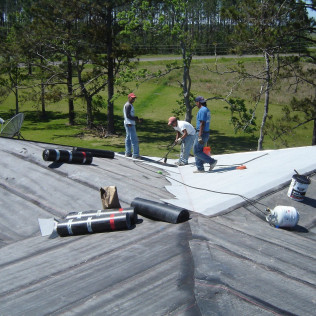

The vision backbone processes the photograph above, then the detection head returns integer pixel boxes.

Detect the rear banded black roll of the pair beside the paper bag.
[65,207,137,224]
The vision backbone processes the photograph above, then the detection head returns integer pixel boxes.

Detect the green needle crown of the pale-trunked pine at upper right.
[222,0,310,54]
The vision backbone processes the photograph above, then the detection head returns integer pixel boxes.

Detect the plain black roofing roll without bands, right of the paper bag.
[131,198,190,224]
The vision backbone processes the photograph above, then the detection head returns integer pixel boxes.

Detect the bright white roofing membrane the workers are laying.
[143,146,316,215]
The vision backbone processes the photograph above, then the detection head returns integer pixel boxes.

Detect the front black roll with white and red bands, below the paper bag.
[56,213,131,237]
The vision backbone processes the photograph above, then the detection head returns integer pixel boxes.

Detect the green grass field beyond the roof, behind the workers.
[0,58,313,158]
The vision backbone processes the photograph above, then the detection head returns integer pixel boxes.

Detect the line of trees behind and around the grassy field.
[0,0,316,149]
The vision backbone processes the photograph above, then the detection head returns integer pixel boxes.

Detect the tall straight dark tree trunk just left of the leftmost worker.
[106,6,115,135]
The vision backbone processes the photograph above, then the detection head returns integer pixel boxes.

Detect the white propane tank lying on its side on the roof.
[266,205,300,228]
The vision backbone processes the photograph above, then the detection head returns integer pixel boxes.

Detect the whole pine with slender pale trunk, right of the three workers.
[224,0,310,150]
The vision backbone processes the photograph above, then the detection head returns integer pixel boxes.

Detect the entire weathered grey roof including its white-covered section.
[0,138,316,315]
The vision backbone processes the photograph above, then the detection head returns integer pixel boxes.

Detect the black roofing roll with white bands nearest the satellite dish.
[43,149,93,165]
